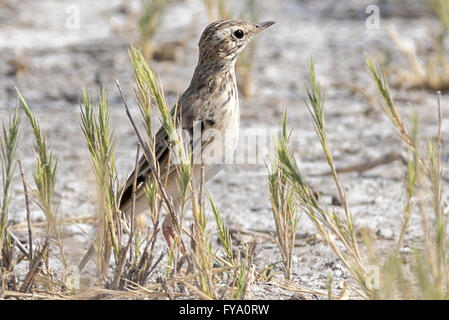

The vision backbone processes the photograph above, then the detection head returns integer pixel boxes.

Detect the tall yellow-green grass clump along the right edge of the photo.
[367,57,449,299]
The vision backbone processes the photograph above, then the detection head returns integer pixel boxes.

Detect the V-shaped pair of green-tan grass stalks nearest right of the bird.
[276,61,371,297]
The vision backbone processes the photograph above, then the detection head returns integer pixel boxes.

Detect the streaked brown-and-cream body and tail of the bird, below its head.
[120,66,240,214]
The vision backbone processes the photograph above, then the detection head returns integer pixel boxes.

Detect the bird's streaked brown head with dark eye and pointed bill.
[199,20,275,62]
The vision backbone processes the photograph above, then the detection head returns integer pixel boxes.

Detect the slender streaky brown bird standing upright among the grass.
[80,20,275,266]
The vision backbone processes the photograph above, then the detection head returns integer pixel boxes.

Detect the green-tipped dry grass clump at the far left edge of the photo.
[0,90,67,297]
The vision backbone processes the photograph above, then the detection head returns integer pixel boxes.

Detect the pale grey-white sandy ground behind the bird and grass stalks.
[0,0,449,299]
